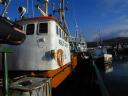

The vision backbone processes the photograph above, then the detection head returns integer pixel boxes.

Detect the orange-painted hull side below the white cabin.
[32,55,77,88]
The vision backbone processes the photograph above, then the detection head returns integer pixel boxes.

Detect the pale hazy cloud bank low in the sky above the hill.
[89,16,128,41]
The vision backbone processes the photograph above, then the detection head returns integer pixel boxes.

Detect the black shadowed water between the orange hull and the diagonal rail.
[53,57,101,96]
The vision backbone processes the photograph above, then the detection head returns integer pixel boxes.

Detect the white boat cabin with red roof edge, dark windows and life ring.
[9,16,71,71]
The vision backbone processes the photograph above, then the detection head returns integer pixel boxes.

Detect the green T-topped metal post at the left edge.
[0,47,13,96]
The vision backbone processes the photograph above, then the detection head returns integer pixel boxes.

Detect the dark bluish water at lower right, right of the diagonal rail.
[104,55,128,96]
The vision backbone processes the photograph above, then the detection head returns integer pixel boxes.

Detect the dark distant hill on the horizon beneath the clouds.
[87,37,128,47]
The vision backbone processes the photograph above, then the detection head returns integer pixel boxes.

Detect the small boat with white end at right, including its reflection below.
[94,46,113,73]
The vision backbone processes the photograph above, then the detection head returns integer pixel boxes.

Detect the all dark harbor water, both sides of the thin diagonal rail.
[53,56,128,96]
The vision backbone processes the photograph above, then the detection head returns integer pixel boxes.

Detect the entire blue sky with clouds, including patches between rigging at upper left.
[0,0,128,41]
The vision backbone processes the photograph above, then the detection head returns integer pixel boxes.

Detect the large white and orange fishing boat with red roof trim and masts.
[0,0,77,88]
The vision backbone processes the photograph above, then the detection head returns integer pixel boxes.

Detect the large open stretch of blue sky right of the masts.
[68,0,128,41]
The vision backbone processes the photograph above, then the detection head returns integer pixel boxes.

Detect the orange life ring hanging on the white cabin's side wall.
[57,49,64,66]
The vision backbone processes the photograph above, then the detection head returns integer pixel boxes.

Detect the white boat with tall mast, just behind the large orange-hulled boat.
[69,19,89,59]
